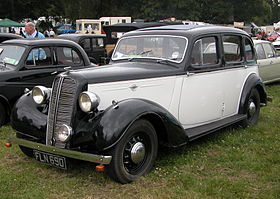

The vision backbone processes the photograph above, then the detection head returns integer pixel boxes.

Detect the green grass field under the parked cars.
[0,84,280,199]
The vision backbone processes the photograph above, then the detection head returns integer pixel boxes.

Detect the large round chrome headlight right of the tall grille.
[79,91,100,112]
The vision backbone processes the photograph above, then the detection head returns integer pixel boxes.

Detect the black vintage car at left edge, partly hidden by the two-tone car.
[0,39,95,125]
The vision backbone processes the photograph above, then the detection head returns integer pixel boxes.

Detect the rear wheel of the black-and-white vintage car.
[241,88,260,127]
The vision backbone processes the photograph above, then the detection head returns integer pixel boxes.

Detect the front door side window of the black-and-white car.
[191,37,218,68]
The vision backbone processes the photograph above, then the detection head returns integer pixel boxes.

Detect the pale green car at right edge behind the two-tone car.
[254,40,280,83]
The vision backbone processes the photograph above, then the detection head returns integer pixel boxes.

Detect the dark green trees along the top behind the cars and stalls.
[0,0,280,25]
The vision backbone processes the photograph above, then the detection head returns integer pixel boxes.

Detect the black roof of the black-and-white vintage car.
[122,24,249,36]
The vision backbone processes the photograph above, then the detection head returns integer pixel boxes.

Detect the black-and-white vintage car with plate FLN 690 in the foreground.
[6,25,267,183]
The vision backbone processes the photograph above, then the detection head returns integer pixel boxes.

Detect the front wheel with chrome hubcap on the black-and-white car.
[107,119,158,184]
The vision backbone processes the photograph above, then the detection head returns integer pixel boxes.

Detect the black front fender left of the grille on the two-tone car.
[11,92,47,143]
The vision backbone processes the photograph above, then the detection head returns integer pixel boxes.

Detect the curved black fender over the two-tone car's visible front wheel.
[73,99,187,151]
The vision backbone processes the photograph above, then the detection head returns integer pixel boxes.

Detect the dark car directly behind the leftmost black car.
[58,34,107,64]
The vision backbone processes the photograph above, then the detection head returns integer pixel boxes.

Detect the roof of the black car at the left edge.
[2,38,82,46]
